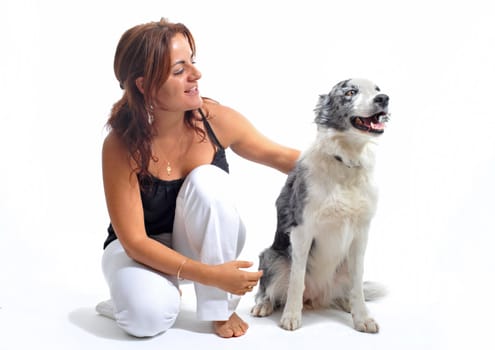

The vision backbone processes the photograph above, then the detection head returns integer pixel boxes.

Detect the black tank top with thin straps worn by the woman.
[103,110,229,248]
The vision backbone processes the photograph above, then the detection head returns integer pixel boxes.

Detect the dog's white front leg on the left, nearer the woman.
[280,226,312,331]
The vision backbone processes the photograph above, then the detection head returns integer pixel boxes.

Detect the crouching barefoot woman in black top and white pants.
[97,19,299,338]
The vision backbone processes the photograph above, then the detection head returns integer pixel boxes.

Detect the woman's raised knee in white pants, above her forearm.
[173,165,245,264]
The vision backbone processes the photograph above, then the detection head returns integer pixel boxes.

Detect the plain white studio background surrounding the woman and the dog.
[0,0,495,349]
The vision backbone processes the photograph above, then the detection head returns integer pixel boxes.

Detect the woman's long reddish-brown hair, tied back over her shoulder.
[107,18,204,183]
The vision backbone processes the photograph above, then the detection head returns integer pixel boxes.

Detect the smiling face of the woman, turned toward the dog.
[153,33,202,113]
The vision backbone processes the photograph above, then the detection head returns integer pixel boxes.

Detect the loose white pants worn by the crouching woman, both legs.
[102,165,245,337]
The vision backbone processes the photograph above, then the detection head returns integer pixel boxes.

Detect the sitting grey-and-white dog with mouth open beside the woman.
[251,79,389,333]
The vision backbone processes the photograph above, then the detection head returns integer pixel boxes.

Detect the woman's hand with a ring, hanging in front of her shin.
[211,260,263,295]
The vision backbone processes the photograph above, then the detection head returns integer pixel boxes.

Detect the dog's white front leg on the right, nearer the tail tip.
[348,230,379,333]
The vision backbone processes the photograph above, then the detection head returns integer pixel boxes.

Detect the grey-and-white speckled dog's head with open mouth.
[315,79,389,135]
